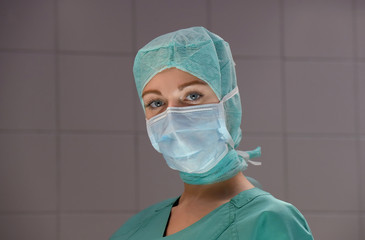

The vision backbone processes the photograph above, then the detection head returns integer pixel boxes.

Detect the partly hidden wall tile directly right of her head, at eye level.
[235,59,282,132]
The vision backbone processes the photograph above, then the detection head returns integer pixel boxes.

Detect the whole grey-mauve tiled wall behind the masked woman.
[0,0,365,240]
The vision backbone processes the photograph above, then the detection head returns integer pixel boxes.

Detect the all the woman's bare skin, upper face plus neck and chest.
[142,68,254,236]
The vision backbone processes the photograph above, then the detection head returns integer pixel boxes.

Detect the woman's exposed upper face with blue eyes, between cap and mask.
[142,68,219,119]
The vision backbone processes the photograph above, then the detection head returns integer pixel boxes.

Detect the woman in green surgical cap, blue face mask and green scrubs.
[111,27,313,240]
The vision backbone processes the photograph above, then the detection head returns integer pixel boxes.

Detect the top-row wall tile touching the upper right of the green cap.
[211,0,280,56]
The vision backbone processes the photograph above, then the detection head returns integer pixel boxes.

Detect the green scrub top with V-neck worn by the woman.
[110,188,313,240]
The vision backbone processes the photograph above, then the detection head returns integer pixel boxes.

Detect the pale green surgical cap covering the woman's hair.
[133,27,242,147]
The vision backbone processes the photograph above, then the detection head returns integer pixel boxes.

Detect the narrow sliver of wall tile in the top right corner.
[355,0,365,58]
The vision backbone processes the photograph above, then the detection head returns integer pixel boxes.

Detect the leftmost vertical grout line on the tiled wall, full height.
[54,0,61,240]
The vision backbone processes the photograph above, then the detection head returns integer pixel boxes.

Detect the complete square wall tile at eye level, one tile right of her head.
[286,62,355,133]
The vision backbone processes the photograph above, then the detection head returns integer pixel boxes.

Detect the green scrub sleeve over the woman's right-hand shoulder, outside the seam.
[232,191,313,240]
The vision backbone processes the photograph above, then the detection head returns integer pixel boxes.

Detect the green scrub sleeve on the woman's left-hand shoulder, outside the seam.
[110,198,177,240]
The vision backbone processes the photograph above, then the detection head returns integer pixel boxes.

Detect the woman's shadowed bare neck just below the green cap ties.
[179,172,254,205]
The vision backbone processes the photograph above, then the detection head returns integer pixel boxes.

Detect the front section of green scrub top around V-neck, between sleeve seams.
[138,188,267,240]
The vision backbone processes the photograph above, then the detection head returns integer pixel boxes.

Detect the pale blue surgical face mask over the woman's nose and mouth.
[147,88,238,173]
